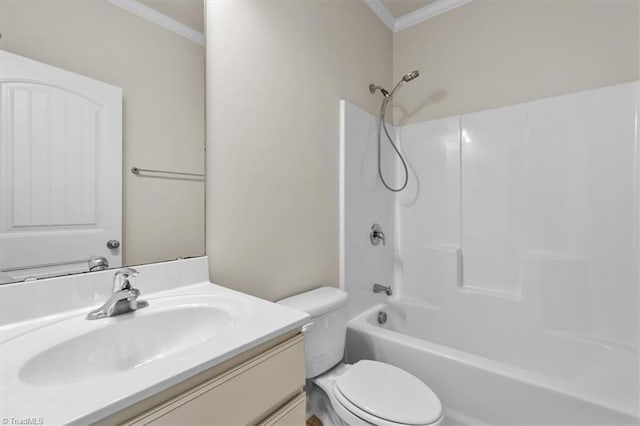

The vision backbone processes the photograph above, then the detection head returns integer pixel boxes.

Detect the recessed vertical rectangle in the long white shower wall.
[461,105,527,296]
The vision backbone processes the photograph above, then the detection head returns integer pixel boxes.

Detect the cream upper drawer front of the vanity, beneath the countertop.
[129,335,305,425]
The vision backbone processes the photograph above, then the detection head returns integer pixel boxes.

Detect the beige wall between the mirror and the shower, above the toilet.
[207,0,392,300]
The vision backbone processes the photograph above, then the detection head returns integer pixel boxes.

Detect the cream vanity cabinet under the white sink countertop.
[102,333,306,425]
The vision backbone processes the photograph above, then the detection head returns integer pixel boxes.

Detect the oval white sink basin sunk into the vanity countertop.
[18,306,233,385]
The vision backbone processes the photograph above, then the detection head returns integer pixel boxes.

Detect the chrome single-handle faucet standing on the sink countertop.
[87,268,149,320]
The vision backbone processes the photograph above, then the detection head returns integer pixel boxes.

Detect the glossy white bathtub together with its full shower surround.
[341,82,640,424]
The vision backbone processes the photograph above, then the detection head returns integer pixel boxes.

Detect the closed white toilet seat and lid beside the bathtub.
[314,360,442,426]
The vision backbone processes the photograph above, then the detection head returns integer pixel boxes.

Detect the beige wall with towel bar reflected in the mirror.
[0,0,204,264]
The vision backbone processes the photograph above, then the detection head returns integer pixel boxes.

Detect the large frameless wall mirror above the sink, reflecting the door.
[0,0,205,283]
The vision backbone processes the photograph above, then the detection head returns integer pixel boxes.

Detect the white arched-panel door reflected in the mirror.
[0,50,122,282]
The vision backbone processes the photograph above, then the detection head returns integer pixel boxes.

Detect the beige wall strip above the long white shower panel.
[393,0,640,123]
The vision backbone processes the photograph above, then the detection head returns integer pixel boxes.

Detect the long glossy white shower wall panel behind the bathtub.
[395,82,640,404]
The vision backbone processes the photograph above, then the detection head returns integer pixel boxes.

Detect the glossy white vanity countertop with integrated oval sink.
[0,272,308,425]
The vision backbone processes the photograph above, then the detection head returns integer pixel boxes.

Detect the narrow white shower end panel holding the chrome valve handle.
[340,101,397,316]
